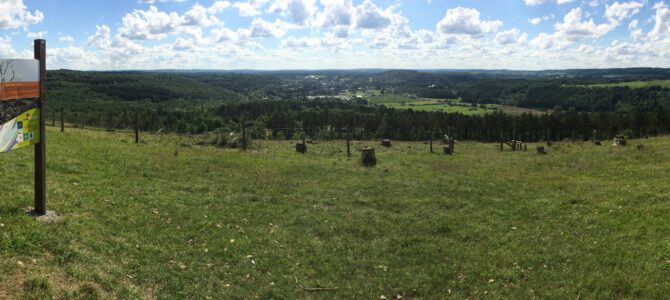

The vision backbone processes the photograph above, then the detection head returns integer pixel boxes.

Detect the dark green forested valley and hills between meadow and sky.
[42,69,670,141]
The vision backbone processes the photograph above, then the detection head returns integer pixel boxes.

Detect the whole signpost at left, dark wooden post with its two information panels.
[0,40,47,216]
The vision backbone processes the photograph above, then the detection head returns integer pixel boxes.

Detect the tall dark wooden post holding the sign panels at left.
[34,39,47,215]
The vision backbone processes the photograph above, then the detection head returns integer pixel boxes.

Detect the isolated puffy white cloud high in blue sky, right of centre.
[437,7,503,37]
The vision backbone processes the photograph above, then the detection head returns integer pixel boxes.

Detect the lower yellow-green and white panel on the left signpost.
[0,108,40,152]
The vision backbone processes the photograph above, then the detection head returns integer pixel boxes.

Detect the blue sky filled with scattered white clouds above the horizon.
[0,0,670,70]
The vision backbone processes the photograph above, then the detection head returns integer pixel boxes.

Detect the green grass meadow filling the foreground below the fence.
[0,128,670,299]
